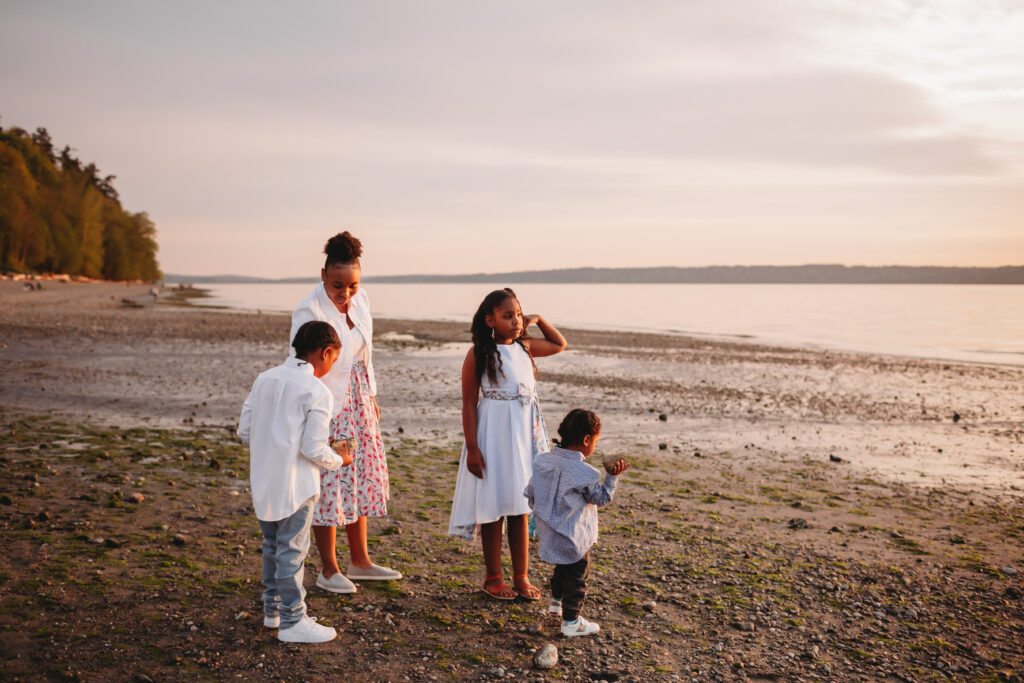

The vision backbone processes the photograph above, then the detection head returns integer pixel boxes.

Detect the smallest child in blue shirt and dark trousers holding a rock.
[523,408,630,637]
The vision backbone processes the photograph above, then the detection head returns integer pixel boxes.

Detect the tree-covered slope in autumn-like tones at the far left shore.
[0,122,161,281]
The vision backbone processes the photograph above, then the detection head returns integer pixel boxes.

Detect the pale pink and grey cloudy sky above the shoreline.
[0,0,1024,278]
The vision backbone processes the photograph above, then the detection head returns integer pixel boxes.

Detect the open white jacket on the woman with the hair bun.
[288,283,377,417]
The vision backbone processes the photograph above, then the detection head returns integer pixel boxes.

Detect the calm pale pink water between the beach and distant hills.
[184,284,1024,365]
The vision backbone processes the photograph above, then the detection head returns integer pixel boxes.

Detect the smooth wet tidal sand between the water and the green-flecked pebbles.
[0,282,1024,494]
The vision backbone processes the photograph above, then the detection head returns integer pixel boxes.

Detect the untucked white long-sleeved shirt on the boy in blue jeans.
[238,357,342,521]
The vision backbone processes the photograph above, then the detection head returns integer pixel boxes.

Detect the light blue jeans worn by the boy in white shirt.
[259,497,316,629]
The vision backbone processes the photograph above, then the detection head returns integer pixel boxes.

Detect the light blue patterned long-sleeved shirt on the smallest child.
[523,446,618,564]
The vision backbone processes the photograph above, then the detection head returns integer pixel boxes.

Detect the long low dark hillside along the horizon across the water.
[164,264,1024,285]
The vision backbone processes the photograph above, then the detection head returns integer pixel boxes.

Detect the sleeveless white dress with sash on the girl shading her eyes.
[449,343,551,539]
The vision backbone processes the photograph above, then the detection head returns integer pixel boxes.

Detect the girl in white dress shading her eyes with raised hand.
[449,288,565,600]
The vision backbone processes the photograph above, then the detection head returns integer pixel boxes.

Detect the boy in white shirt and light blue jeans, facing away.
[238,322,352,643]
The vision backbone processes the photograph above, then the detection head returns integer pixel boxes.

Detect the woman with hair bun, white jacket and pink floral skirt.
[292,231,401,593]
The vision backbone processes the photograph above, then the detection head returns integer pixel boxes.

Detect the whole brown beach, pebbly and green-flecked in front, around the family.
[0,281,1024,681]
